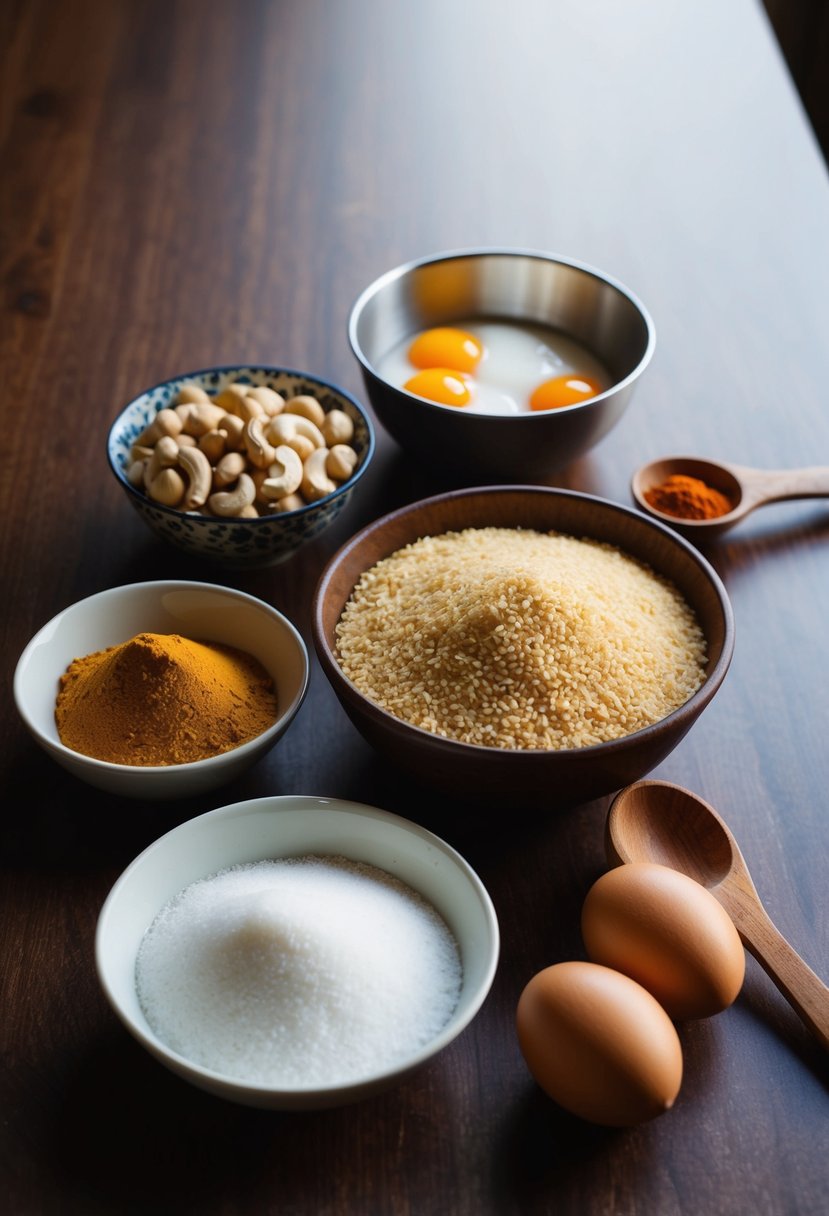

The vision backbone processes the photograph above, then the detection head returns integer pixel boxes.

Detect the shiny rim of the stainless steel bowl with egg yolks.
[348,246,656,427]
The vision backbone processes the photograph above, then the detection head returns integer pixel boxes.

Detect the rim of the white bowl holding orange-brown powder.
[12,579,311,779]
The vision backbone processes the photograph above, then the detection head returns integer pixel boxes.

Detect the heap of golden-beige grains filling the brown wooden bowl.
[337,528,706,749]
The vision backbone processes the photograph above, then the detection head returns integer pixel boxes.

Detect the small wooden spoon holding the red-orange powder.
[631,456,829,539]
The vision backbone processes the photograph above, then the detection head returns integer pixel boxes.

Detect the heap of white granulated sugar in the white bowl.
[136,856,461,1088]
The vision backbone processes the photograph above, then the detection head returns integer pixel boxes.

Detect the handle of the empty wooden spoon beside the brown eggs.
[716,890,829,1049]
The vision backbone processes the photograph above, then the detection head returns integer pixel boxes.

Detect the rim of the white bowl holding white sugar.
[95,794,501,1105]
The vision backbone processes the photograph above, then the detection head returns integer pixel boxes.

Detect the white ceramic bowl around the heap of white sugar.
[95,796,500,1109]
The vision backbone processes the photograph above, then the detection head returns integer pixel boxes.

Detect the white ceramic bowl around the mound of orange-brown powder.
[15,581,309,799]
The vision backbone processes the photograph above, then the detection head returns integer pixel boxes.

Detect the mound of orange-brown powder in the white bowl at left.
[55,634,277,765]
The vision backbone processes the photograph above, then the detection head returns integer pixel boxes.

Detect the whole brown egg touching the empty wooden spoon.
[581,862,745,1020]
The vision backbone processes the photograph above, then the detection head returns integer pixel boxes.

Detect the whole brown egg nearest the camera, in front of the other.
[515,962,682,1127]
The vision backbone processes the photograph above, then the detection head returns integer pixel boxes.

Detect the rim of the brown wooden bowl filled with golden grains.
[311,484,735,749]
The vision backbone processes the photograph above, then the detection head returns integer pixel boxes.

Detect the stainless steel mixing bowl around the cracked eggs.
[348,248,655,482]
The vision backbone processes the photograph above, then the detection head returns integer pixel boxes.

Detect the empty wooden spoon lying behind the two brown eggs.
[605,781,829,1048]
